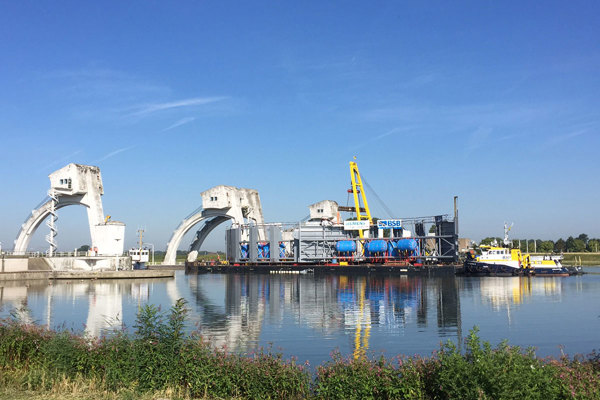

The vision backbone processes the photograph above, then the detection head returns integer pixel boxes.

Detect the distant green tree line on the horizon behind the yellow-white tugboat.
[479,233,600,253]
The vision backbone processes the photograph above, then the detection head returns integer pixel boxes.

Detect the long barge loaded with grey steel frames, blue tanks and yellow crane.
[186,162,458,273]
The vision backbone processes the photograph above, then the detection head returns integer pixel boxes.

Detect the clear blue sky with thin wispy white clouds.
[0,1,600,250]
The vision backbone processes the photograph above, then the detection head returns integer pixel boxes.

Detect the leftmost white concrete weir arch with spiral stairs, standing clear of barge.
[13,163,125,270]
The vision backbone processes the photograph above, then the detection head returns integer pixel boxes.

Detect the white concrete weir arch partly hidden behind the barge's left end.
[164,185,265,265]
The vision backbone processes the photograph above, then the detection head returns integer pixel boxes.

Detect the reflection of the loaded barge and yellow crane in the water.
[189,274,460,357]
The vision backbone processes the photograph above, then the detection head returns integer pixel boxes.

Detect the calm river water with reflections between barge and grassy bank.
[0,268,600,365]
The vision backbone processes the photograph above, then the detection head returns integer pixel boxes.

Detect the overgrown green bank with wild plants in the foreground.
[0,300,600,400]
